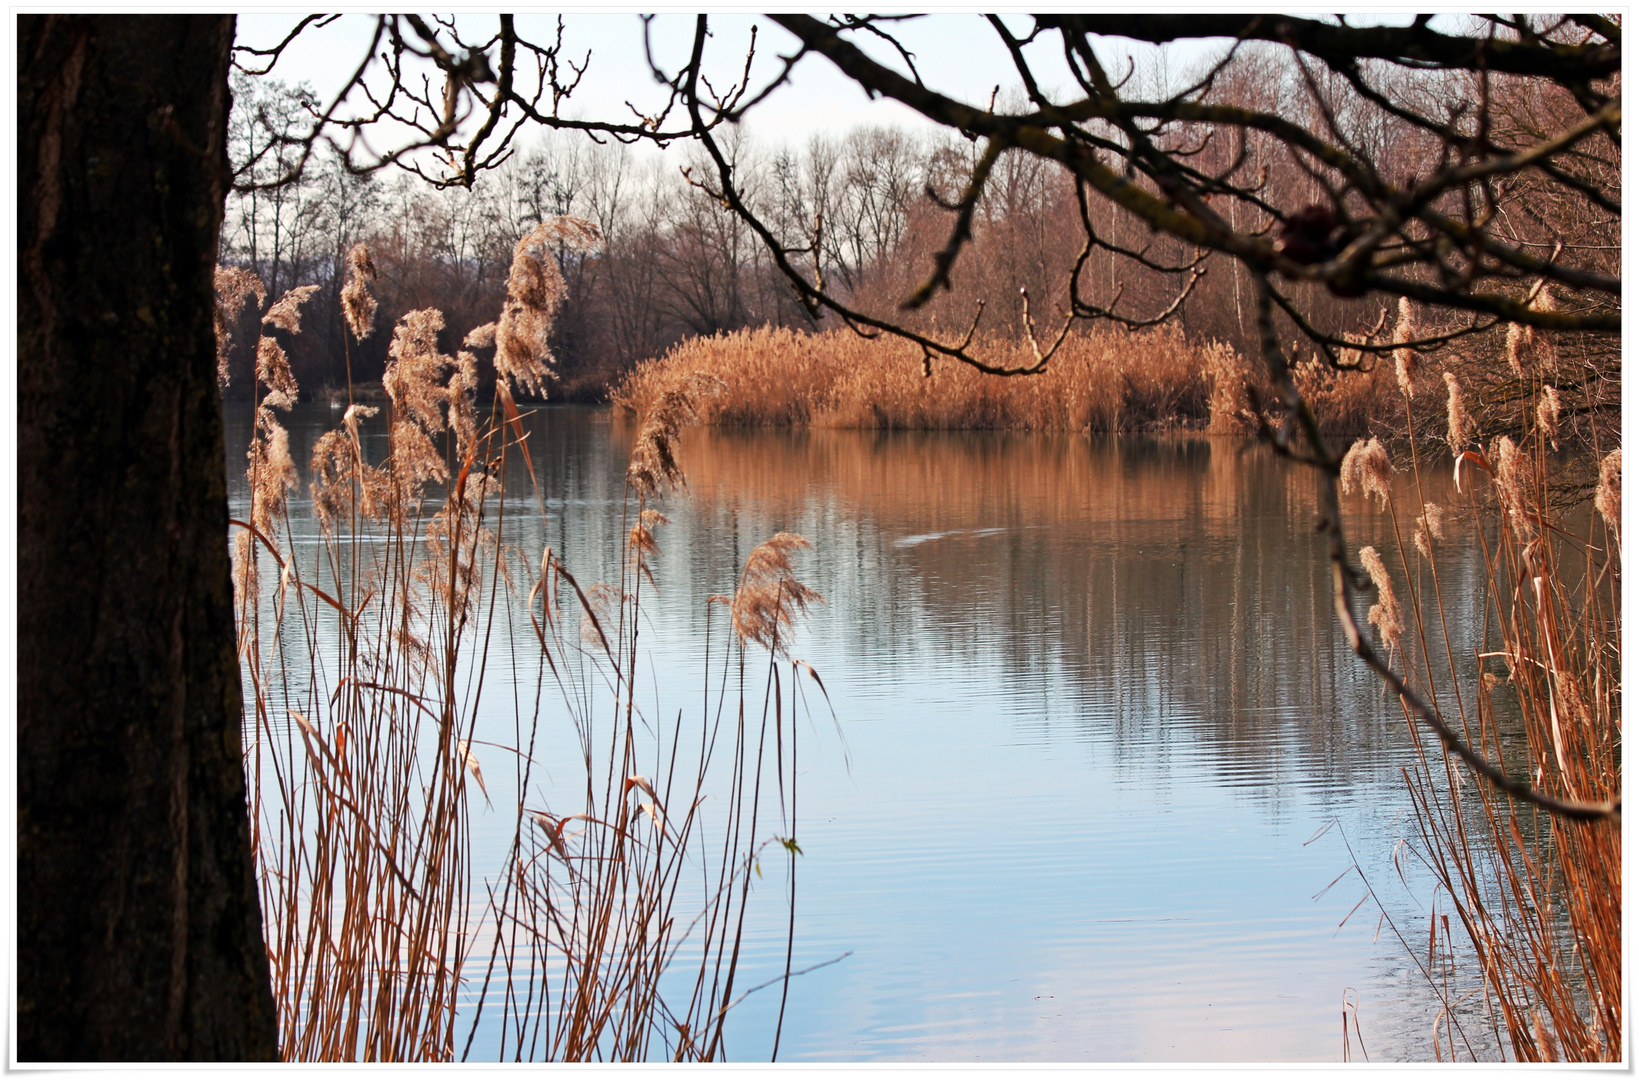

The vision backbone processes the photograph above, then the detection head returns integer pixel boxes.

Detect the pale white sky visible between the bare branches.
[239,13,1216,163]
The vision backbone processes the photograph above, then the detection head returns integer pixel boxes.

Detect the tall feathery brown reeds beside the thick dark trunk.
[227,220,818,1062]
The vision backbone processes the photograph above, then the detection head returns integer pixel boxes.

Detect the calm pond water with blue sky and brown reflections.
[229,406,1501,1062]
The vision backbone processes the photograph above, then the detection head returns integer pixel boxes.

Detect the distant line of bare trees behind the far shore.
[221,49,1621,455]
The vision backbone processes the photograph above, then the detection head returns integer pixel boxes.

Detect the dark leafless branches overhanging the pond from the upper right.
[243,15,1621,818]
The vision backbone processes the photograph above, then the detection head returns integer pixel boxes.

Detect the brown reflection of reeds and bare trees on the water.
[237,410,1483,812]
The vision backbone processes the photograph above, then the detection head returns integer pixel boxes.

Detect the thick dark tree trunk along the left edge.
[16,15,275,1060]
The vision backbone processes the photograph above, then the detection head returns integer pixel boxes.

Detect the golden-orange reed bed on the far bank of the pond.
[610,326,1395,433]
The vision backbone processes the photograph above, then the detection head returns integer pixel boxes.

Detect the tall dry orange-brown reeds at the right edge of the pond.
[1344,375,1623,1062]
